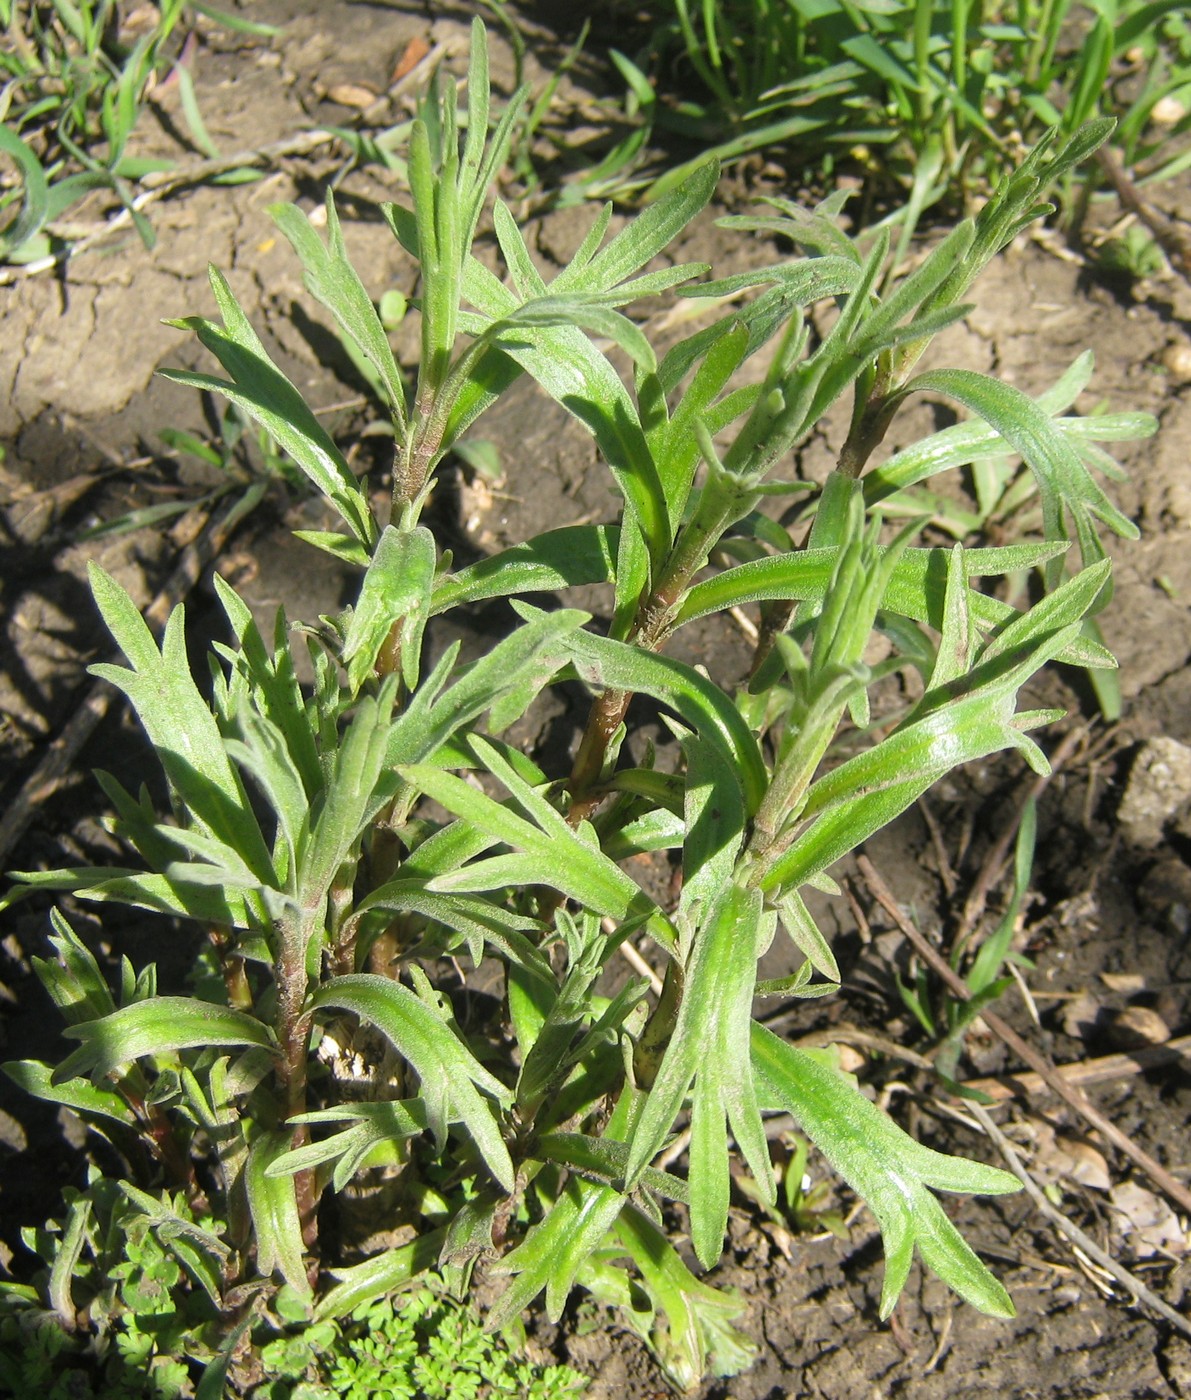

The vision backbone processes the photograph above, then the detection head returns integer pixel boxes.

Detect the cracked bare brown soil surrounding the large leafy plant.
[0,0,1191,1400]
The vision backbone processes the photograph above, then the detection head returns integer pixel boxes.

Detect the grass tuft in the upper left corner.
[0,0,276,262]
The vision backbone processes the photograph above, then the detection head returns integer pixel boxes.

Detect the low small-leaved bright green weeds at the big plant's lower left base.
[0,1170,586,1400]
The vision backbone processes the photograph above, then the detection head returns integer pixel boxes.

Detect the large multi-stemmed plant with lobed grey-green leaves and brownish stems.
[0,25,1153,1386]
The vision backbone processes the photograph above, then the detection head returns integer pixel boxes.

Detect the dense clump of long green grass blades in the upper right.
[617,0,1191,218]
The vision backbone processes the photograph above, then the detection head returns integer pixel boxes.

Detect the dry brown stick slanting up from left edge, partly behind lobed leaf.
[0,487,260,864]
